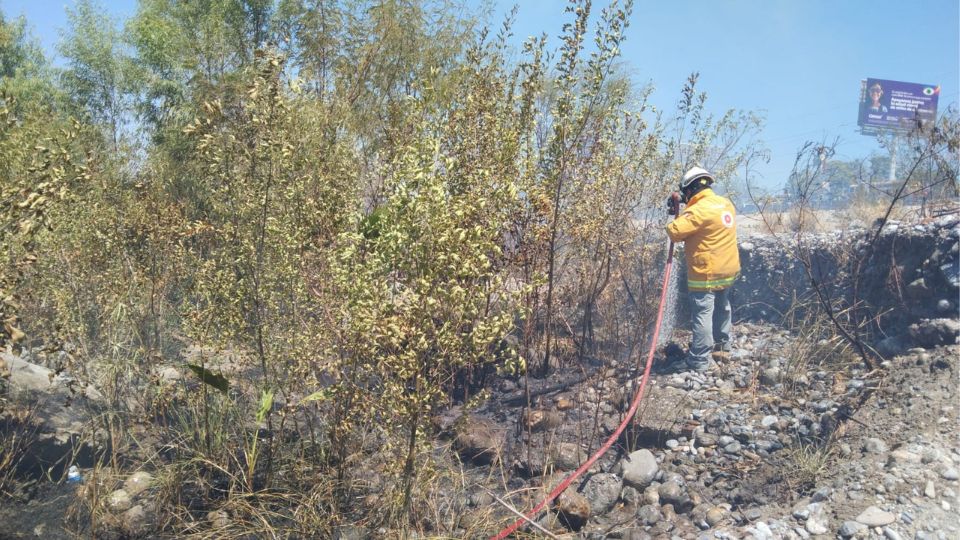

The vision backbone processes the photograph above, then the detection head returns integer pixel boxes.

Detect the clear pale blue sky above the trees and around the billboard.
[0,0,960,190]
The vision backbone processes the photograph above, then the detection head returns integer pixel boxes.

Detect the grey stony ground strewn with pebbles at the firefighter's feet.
[446,324,960,539]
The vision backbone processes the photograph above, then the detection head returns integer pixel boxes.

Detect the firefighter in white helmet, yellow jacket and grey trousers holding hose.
[667,167,740,372]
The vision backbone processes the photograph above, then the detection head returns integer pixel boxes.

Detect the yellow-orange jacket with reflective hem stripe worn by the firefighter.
[667,188,740,291]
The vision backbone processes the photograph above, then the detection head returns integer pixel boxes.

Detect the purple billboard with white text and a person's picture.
[857,79,940,135]
